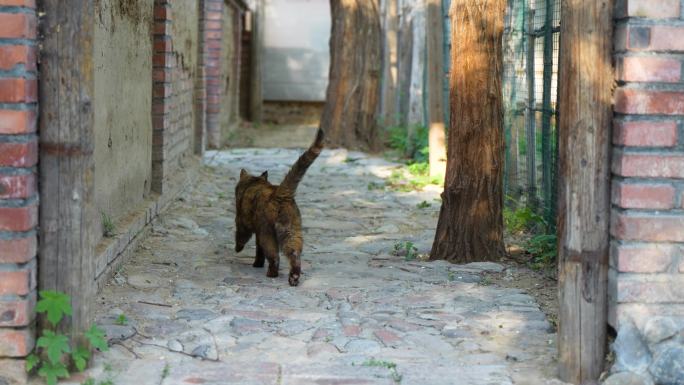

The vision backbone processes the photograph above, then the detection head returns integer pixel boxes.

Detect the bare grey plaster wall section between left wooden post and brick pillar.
[93,0,153,228]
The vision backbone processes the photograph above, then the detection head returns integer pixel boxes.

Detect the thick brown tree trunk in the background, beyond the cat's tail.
[321,0,382,150]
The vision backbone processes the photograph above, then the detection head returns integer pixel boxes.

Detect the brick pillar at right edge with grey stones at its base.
[609,0,684,384]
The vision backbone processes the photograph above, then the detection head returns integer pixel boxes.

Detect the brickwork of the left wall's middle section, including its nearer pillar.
[152,0,197,193]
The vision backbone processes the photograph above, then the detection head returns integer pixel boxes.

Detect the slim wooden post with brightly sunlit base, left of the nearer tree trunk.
[426,0,446,176]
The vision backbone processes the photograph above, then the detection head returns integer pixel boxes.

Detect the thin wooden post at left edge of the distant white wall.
[249,0,265,123]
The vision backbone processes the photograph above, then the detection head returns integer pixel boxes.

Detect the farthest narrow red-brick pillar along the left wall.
[200,0,224,148]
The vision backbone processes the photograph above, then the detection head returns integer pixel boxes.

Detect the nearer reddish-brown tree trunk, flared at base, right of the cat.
[430,0,505,263]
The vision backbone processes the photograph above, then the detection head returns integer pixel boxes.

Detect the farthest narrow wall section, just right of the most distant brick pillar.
[219,6,239,144]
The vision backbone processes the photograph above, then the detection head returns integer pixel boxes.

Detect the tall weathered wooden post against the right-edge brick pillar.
[558,0,614,384]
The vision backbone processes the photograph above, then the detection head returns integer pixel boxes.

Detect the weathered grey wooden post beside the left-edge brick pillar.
[38,0,99,339]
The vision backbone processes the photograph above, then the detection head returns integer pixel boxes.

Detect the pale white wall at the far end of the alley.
[262,0,331,101]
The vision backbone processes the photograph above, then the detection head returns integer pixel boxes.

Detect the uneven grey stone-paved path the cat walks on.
[58,149,560,385]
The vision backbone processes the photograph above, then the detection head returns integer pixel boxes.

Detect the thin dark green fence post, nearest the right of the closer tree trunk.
[525,4,537,208]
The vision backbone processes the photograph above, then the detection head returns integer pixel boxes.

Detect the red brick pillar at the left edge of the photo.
[0,0,38,384]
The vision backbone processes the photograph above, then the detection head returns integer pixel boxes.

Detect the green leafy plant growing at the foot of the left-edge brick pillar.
[26,290,108,385]
